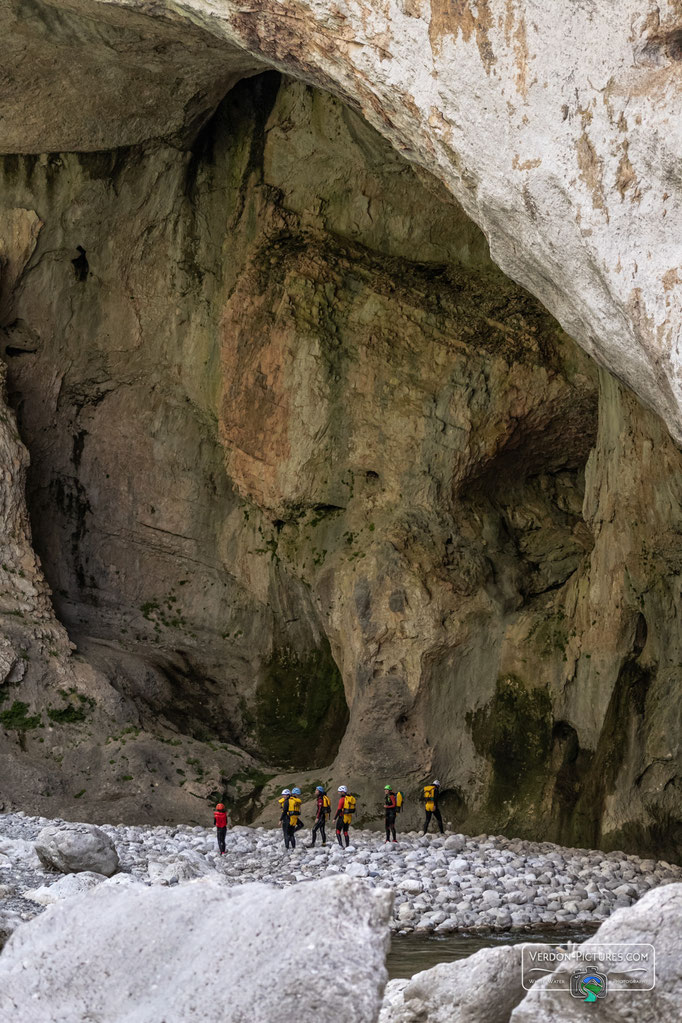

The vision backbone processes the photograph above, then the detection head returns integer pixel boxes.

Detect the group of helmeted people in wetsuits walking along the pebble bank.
[214,781,443,856]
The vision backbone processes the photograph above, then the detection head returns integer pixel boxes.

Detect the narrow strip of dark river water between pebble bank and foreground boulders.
[387,930,594,980]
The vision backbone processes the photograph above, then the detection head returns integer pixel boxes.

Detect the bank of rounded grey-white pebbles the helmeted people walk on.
[0,813,682,935]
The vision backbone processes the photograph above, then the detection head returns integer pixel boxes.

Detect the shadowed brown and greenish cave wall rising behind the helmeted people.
[0,69,682,856]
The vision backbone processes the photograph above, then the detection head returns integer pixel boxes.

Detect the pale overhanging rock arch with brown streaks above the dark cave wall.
[0,0,682,442]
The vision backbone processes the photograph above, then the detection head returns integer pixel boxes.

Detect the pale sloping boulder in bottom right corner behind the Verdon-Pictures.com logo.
[511,884,682,1023]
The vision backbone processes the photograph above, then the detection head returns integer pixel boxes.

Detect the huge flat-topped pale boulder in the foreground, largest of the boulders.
[0,877,393,1023]
